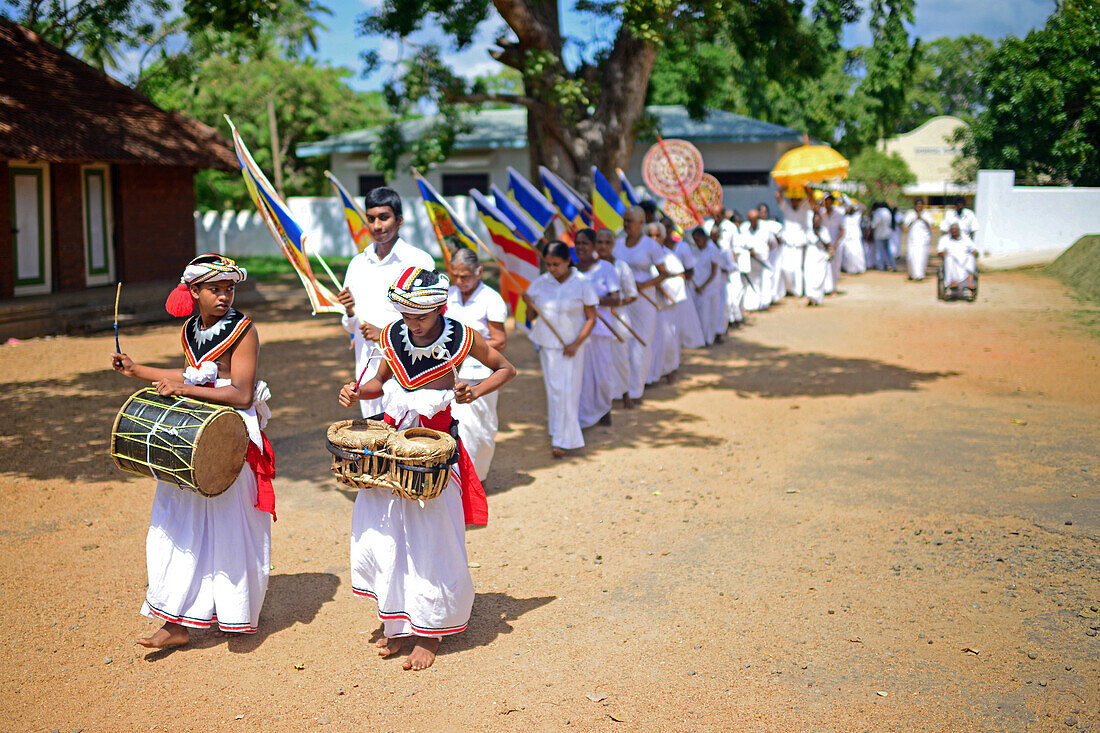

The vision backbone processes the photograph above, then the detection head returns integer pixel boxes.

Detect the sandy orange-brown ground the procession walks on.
[0,273,1100,732]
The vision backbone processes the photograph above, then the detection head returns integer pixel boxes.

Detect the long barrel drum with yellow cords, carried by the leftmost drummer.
[111,387,249,496]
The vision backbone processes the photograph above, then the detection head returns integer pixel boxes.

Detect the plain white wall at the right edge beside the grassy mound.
[975,171,1100,267]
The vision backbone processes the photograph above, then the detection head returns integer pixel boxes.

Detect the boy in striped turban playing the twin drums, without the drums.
[339,267,516,670]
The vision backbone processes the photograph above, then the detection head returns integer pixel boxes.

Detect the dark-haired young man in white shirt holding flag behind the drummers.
[337,187,436,417]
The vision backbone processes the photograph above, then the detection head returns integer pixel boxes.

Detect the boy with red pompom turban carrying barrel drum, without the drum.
[111,254,275,647]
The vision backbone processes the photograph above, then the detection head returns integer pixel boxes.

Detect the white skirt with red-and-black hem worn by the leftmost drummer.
[141,463,272,633]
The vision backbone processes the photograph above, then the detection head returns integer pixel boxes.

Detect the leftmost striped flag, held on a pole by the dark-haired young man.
[226,117,344,315]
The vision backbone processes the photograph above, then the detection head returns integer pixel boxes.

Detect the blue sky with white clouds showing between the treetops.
[317,0,1055,90]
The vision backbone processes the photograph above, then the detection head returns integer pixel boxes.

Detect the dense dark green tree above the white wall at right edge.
[964,0,1100,186]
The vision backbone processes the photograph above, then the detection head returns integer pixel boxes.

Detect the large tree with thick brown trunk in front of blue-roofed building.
[362,0,836,183]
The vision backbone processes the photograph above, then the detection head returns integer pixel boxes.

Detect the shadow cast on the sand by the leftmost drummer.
[145,572,340,661]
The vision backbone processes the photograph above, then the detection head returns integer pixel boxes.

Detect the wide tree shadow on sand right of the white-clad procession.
[681,337,958,398]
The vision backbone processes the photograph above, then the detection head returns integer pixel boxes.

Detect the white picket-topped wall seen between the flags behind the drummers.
[195,196,488,258]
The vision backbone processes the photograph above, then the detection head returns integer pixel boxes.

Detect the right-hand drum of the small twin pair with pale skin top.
[388,427,459,500]
